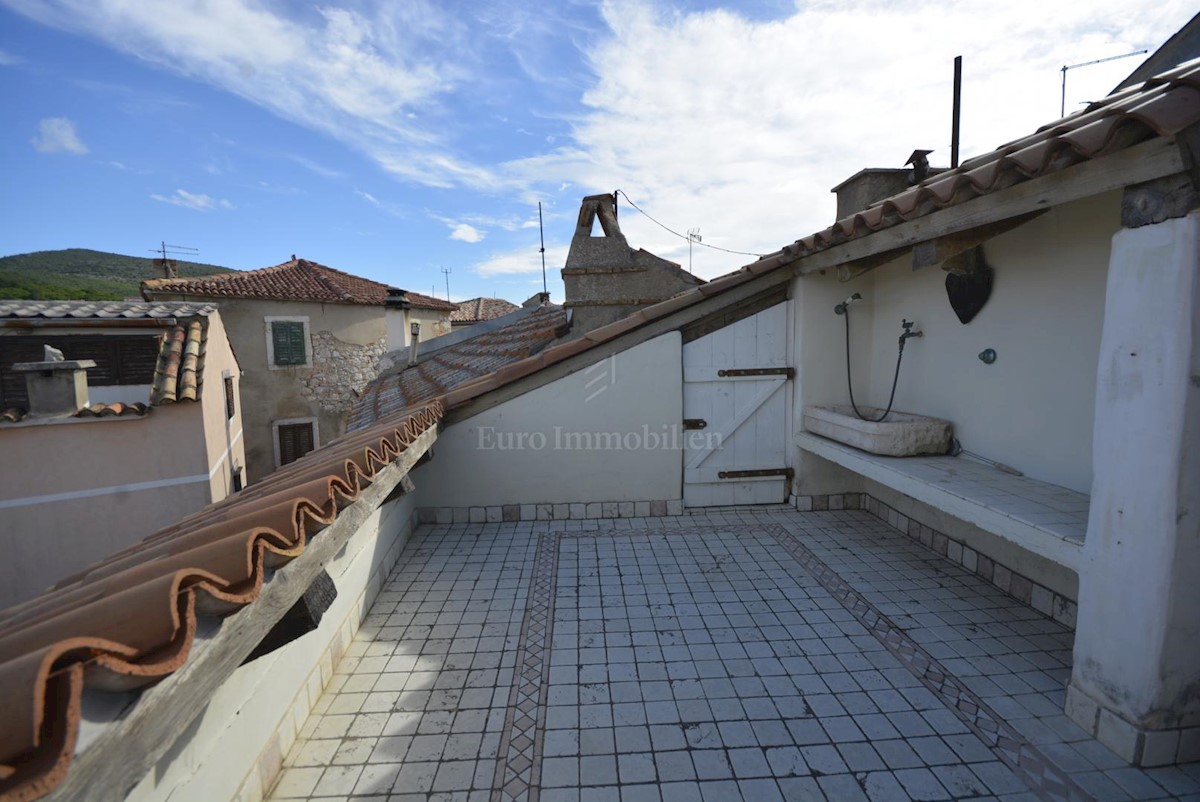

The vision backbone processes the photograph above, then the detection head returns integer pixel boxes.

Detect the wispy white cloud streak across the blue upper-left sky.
[5,0,496,187]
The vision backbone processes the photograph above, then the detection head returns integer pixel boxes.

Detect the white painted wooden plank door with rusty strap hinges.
[683,303,791,507]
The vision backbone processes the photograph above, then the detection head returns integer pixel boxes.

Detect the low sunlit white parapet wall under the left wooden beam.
[126,493,415,802]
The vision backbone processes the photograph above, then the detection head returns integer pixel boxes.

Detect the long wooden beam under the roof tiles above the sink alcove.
[794,137,1184,275]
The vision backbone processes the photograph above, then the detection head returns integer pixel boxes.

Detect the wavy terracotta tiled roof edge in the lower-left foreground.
[0,402,442,802]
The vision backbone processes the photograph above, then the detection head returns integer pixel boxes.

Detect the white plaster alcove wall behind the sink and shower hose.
[796,192,1121,492]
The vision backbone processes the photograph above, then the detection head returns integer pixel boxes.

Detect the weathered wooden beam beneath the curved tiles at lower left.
[44,426,438,802]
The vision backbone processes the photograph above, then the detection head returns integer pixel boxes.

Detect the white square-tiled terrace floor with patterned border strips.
[272,508,1200,802]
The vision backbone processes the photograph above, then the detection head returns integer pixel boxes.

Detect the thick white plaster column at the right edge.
[1062,211,1200,766]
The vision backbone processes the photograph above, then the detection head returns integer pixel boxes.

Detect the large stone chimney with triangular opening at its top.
[563,194,704,335]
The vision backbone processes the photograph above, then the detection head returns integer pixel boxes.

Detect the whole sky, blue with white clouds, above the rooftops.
[0,0,1193,301]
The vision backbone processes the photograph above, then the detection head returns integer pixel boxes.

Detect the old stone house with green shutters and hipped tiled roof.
[142,257,456,483]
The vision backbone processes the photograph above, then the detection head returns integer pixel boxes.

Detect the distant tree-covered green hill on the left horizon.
[0,247,232,300]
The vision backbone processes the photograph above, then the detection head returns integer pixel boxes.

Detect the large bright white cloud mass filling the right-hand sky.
[505,0,1194,277]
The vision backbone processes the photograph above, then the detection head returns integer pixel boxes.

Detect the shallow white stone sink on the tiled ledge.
[804,406,954,456]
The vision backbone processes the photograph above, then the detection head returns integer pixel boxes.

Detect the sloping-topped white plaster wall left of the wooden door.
[414,331,683,507]
